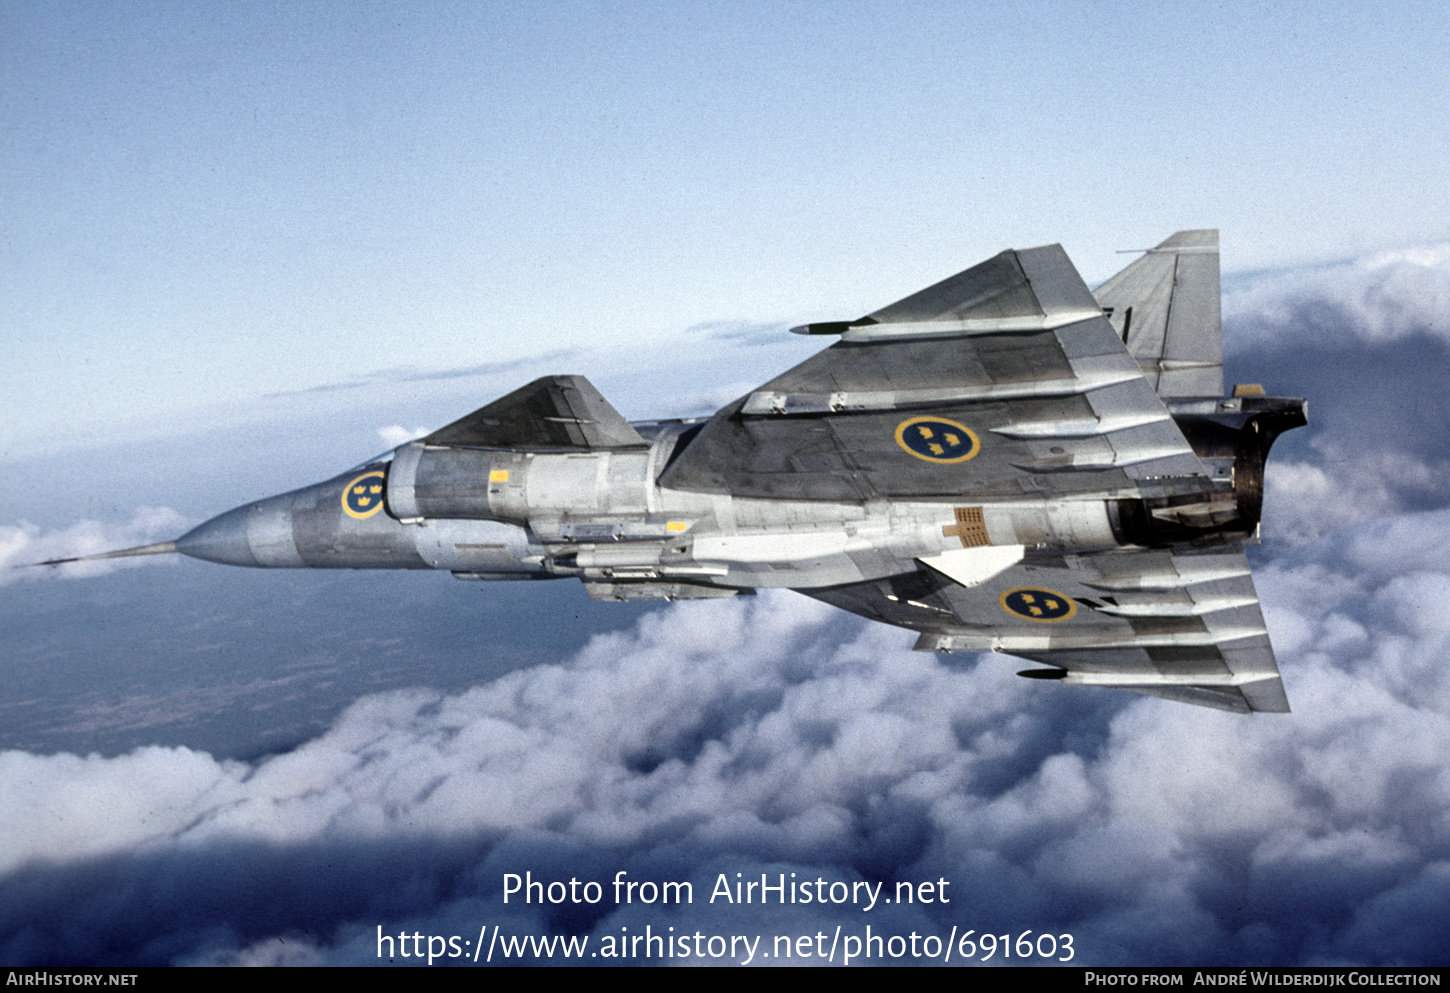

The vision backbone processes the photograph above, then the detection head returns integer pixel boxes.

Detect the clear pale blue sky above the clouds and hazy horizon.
[0,3,1450,455]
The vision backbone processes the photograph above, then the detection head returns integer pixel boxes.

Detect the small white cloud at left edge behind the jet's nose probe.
[0,507,193,586]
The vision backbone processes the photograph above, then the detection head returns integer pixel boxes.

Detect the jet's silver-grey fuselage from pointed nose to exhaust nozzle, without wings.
[177,397,1302,599]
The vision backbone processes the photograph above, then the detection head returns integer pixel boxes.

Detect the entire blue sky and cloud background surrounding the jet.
[0,3,1450,965]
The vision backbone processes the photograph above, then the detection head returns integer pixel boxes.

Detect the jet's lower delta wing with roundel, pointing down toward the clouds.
[806,549,1289,713]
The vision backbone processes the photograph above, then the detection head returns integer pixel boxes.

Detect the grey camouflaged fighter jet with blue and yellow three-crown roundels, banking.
[49,230,1306,713]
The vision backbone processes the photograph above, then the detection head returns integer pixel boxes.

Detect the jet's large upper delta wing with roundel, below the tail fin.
[660,245,1212,500]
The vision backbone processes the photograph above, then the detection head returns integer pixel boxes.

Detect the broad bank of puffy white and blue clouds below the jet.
[8,512,1450,964]
